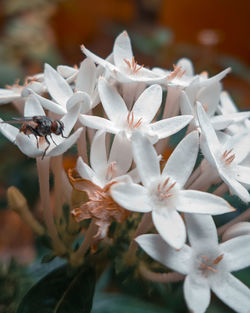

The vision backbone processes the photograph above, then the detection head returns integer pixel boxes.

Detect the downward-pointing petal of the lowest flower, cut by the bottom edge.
[183,275,211,313]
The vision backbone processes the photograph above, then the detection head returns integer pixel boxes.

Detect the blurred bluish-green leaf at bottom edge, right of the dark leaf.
[91,293,173,313]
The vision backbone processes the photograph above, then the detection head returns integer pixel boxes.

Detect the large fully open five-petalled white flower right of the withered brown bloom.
[111,131,231,249]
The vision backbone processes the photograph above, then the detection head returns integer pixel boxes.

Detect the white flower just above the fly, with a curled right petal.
[30,64,91,115]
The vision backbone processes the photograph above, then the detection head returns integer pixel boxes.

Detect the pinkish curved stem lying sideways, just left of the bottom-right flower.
[139,265,185,283]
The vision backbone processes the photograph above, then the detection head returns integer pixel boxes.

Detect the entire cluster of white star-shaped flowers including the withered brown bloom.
[0,32,250,313]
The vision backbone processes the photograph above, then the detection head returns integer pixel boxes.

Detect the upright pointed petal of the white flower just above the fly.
[44,64,73,105]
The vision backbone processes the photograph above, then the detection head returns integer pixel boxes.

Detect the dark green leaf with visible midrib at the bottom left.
[16,265,95,313]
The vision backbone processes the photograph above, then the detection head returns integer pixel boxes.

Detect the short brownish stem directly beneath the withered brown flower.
[70,219,97,266]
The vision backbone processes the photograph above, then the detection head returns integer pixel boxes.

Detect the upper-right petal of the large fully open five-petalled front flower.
[162,131,199,187]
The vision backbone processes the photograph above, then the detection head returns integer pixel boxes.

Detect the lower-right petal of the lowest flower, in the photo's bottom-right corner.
[211,273,250,313]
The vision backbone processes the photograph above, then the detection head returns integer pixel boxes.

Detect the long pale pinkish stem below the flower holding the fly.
[36,157,66,255]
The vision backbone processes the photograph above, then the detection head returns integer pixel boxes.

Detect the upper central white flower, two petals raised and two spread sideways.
[79,78,192,143]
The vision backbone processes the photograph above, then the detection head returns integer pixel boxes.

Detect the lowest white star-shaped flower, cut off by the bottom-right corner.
[136,214,250,313]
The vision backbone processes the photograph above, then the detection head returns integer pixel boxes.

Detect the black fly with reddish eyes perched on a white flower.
[1,116,68,159]
